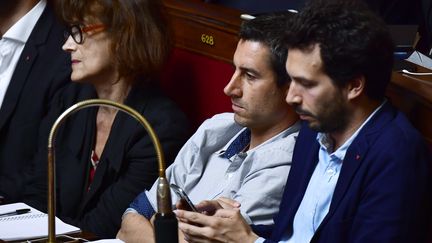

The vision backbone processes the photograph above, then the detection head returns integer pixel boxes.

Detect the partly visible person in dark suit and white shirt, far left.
[0,0,70,203]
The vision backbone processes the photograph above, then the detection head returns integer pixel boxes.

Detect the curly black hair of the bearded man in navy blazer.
[285,0,394,100]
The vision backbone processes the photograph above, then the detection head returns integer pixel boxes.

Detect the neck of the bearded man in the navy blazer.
[329,99,381,151]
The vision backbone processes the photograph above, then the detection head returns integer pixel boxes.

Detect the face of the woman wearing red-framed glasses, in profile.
[63,18,117,84]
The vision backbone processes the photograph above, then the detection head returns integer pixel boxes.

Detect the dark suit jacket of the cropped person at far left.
[0,3,71,203]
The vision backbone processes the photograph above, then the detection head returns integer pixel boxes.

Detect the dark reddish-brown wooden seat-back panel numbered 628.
[163,0,241,63]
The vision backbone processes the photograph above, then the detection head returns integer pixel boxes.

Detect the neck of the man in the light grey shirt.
[249,112,298,149]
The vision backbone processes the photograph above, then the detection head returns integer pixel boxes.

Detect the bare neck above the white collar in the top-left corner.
[0,0,39,35]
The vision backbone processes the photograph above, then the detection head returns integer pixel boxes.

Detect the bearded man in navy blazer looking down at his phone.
[177,1,432,243]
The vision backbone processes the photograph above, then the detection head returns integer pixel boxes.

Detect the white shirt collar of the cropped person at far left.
[3,0,47,43]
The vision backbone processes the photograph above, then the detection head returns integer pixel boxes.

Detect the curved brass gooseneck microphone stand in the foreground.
[48,99,178,243]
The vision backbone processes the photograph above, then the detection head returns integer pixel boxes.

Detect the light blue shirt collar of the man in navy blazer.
[316,100,387,161]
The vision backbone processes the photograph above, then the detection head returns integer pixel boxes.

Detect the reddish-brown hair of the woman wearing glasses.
[55,0,172,80]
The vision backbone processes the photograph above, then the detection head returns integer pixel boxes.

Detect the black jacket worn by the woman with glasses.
[25,83,189,238]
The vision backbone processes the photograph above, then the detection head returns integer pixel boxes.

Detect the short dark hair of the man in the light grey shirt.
[239,11,294,85]
